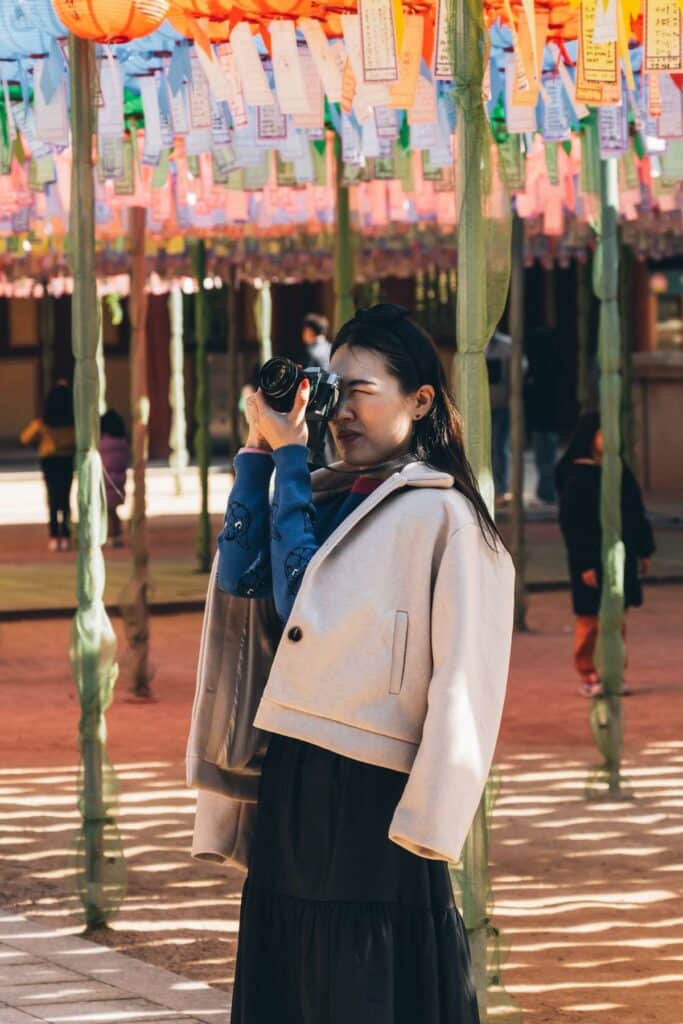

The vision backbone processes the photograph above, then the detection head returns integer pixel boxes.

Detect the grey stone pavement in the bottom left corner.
[0,910,229,1024]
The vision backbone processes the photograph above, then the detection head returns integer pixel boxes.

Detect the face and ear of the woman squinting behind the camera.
[330,345,434,469]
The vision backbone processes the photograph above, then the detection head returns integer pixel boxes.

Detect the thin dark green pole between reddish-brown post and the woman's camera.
[193,241,211,572]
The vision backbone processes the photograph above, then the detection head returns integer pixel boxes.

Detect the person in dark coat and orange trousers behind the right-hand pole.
[555,413,654,696]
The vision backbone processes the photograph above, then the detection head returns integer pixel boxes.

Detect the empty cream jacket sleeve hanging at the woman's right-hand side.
[389,524,514,861]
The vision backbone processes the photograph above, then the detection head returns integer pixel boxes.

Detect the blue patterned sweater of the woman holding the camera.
[218,444,379,622]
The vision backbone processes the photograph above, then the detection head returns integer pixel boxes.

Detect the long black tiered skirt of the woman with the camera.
[231,734,479,1024]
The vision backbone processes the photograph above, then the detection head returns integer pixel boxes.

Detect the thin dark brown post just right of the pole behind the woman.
[509,213,526,632]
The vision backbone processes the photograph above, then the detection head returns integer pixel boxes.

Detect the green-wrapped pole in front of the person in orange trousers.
[591,158,625,796]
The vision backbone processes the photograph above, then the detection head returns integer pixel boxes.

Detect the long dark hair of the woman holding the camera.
[330,302,502,548]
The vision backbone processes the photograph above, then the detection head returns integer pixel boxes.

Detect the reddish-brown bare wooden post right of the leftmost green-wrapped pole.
[128,207,152,698]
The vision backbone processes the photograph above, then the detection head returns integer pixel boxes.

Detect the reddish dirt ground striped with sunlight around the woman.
[0,586,683,1024]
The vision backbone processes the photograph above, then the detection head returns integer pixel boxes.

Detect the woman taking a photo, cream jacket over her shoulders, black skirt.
[188,305,513,1024]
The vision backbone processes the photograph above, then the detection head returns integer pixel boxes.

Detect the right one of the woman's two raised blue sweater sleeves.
[270,444,318,622]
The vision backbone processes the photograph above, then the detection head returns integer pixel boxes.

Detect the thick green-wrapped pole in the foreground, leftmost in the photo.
[69,36,125,929]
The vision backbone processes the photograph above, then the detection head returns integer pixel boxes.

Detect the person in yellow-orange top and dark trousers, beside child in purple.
[20,380,76,551]
